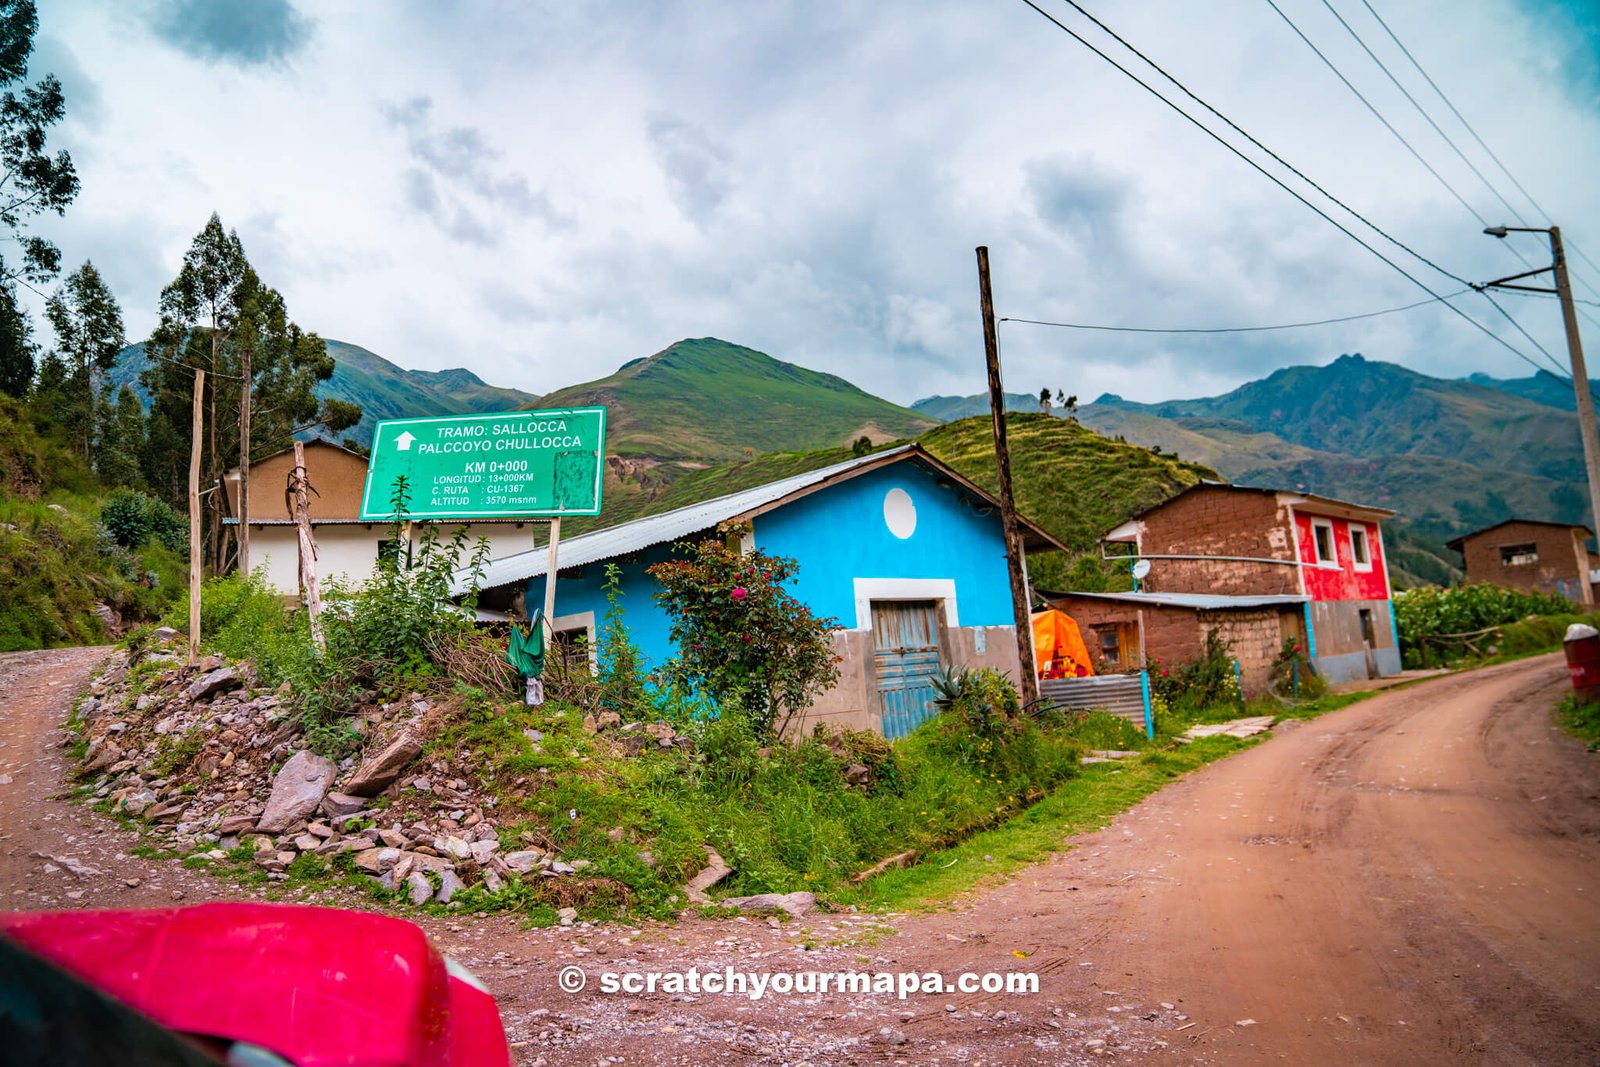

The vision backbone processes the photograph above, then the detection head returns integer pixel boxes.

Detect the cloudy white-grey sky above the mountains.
[34,0,1600,403]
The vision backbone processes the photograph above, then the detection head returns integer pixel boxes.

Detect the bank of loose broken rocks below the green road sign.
[74,630,611,920]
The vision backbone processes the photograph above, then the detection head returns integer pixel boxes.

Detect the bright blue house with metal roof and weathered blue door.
[464,445,1064,737]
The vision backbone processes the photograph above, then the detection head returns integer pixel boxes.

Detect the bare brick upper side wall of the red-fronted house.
[1141,486,1301,595]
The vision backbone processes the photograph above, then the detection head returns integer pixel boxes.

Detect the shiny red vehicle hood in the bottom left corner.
[0,904,510,1067]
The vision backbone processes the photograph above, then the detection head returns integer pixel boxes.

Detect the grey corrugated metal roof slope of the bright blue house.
[451,445,923,593]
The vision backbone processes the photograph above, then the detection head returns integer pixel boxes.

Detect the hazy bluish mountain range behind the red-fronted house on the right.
[915,355,1587,584]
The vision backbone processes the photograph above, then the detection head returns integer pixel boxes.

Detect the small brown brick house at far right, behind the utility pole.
[1448,518,1595,605]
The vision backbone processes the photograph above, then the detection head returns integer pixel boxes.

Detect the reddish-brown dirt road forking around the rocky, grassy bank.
[0,653,1600,1065]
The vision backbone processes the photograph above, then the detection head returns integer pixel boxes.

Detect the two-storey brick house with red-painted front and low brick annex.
[1054,482,1400,684]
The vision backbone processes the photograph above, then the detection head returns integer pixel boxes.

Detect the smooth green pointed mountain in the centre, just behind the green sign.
[538,338,936,462]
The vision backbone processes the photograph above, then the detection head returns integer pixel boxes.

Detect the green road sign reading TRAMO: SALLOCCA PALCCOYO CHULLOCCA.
[362,408,605,520]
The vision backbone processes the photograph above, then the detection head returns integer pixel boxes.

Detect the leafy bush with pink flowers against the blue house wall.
[650,526,838,737]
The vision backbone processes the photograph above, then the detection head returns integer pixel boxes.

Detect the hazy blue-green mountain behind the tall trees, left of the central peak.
[109,341,536,445]
